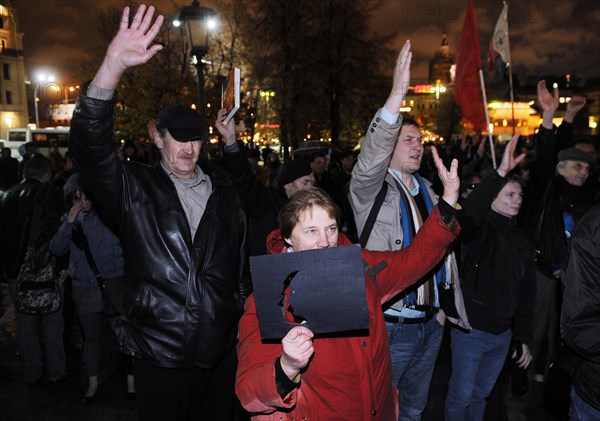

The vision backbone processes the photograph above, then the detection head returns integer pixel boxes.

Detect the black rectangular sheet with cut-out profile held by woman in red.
[250,245,369,339]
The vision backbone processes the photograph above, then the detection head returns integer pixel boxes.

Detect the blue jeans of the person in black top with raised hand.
[445,328,512,421]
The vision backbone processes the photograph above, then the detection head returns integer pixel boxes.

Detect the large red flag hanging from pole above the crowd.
[454,0,487,131]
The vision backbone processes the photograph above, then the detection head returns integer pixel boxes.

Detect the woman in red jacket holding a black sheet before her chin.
[236,147,460,421]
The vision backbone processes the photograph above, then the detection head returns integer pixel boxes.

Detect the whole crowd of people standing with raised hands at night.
[0,5,600,421]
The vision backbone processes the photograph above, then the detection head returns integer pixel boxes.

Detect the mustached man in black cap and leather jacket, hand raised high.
[69,5,248,420]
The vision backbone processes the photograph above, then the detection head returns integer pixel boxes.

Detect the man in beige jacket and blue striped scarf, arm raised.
[349,41,469,421]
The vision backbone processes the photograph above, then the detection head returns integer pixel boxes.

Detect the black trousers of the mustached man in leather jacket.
[133,348,237,421]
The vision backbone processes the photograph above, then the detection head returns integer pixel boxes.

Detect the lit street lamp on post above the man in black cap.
[173,0,216,111]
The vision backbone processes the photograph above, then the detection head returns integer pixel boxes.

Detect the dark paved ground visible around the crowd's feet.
[0,283,553,421]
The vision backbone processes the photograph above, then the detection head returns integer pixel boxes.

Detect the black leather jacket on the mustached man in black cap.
[69,87,249,368]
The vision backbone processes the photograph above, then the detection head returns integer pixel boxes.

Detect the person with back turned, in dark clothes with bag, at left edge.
[0,156,66,385]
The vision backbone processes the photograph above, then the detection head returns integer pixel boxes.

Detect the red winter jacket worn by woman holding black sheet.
[236,206,458,421]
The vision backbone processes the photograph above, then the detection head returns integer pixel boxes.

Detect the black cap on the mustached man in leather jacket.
[156,104,207,142]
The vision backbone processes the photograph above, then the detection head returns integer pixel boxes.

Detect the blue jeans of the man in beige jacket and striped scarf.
[386,317,444,421]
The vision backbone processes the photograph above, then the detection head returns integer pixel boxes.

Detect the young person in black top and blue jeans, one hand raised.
[445,135,536,421]
